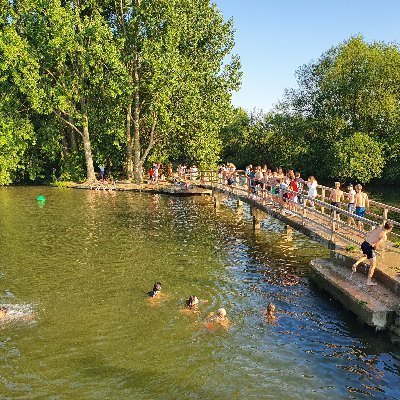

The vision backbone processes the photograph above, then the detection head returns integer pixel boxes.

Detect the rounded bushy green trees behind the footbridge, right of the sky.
[221,37,400,183]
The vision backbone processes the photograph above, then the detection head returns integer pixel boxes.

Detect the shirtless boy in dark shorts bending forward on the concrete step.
[352,222,393,286]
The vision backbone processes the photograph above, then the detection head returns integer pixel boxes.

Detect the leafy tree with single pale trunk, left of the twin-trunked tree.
[14,0,123,181]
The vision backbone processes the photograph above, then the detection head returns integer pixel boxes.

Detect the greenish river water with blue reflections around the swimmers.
[0,187,400,400]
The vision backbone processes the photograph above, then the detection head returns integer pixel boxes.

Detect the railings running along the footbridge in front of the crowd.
[199,170,400,252]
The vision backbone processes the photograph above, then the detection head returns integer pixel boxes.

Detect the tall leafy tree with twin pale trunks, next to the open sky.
[108,0,240,181]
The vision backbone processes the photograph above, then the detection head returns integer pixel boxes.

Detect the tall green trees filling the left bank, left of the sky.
[0,0,241,184]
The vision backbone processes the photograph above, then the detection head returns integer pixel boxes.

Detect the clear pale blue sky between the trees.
[213,0,400,111]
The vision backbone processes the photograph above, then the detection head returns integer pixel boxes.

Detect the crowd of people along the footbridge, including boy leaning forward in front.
[218,164,393,286]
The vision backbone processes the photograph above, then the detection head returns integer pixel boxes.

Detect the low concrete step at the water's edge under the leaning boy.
[310,259,399,330]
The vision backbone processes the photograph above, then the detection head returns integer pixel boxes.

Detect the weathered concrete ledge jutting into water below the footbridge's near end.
[310,259,395,330]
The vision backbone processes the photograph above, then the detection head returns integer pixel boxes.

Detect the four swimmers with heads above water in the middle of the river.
[147,282,276,329]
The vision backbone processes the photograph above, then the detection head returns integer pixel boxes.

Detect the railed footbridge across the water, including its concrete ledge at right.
[193,171,400,341]
